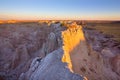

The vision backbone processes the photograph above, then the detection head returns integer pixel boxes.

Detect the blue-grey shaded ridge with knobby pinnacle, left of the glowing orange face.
[19,23,83,80]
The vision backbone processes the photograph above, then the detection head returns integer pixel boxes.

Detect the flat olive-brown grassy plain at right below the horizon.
[86,23,120,42]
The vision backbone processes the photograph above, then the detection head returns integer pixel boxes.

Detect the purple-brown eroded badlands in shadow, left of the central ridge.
[0,23,54,80]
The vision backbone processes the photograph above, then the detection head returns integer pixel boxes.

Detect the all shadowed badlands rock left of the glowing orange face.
[0,23,83,80]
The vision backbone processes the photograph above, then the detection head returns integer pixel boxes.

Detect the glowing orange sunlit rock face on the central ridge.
[62,23,85,71]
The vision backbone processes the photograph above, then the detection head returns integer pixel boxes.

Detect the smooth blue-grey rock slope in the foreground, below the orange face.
[19,48,83,80]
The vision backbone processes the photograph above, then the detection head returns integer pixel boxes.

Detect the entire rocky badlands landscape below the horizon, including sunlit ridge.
[0,21,120,80]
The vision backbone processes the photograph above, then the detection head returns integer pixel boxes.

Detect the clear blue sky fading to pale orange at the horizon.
[0,0,120,20]
